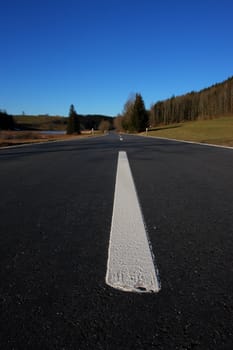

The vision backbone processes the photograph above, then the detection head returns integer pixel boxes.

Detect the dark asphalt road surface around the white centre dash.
[0,134,233,350]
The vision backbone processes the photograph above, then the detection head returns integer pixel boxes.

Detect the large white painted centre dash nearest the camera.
[106,151,160,292]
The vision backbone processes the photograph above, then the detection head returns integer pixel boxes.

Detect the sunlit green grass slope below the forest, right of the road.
[143,117,233,147]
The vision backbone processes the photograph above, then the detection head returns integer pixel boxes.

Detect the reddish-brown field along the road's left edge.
[0,131,102,147]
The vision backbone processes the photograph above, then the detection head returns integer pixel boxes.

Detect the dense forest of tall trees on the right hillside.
[149,77,233,126]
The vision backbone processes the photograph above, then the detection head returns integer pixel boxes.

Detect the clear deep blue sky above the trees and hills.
[0,0,233,116]
